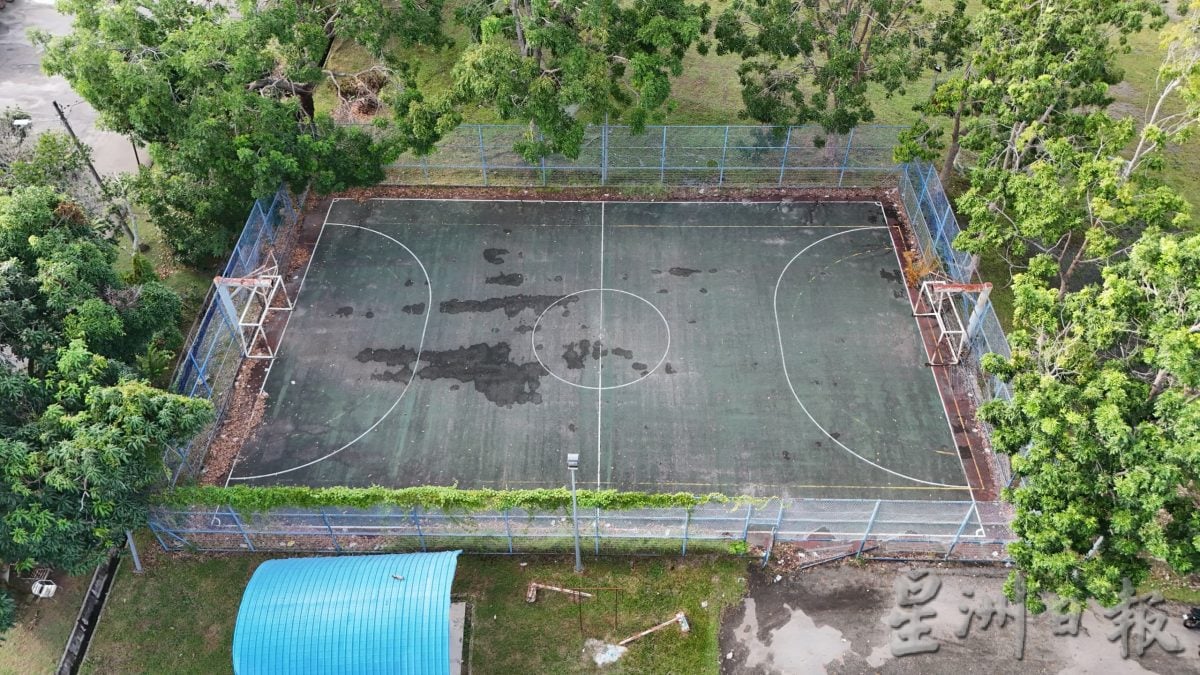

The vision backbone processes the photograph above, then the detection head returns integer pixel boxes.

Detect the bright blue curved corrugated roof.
[233,551,461,675]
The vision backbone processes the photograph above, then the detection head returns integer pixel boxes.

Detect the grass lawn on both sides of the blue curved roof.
[79,542,746,675]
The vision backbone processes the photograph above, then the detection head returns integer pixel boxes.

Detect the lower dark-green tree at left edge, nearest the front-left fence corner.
[0,340,212,574]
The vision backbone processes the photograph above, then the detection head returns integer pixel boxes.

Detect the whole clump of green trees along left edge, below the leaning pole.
[0,135,211,631]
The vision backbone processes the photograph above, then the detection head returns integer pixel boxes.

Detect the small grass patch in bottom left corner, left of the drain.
[0,574,91,675]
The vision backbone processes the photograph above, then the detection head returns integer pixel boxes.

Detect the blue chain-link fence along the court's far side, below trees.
[368,124,902,187]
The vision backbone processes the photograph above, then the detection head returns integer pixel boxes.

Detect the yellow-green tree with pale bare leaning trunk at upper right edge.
[955,5,1200,293]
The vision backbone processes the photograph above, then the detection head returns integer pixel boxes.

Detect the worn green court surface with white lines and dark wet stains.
[232,199,971,500]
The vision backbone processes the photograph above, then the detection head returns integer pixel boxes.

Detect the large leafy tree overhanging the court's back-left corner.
[35,0,446,261]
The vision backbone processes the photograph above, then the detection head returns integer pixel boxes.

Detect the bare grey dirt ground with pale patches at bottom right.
[720,561,1200,675]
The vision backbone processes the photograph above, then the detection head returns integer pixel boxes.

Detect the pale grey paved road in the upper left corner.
[0,0,144,174]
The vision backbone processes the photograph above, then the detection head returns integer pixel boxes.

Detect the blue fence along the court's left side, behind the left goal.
[163,187,298,484]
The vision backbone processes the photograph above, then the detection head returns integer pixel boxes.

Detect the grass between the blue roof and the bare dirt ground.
[455,556,745,675]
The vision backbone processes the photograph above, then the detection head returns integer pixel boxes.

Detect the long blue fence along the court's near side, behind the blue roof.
[150,500,1010,558]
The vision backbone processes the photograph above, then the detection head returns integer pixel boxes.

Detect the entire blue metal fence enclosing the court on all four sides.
[150,131,1012,557]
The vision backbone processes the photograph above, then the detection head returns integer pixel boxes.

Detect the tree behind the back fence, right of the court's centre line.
[715,0,930,133]
